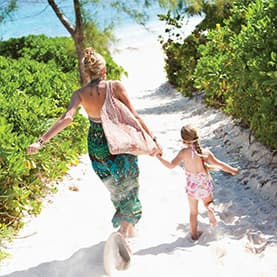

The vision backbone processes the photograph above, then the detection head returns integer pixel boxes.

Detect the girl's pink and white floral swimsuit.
[186,144,213,200]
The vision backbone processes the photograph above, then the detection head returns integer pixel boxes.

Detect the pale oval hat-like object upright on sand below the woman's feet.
[103,232,131,276]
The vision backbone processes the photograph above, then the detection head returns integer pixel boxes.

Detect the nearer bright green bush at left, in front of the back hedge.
[0,57,87,231]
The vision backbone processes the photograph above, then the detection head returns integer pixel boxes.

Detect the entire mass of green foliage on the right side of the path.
[158,0,277,150]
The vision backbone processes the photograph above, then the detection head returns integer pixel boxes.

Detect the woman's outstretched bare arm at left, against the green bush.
[27,91,81,155]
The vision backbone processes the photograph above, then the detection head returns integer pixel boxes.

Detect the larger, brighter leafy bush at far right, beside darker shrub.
[195,0,277,149]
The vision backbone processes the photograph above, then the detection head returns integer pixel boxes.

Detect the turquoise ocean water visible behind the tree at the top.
[0,0,201,47]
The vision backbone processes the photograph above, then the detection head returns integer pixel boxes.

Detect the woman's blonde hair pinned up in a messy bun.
[82,47,106,79]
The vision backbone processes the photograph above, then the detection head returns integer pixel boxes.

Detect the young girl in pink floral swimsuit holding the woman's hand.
[157,125,238,240]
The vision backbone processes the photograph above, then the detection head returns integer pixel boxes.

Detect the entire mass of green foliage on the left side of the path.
[0,36,124,259]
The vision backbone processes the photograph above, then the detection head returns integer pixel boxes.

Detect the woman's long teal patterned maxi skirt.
[88,120,141,228]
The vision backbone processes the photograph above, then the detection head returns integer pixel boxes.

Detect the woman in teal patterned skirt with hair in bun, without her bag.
[27,48,161,238]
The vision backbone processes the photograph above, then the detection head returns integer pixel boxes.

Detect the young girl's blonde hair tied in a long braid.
[181,124,217,174]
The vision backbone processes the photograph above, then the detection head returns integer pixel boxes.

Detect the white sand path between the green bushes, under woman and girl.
[0,24,277,277]
